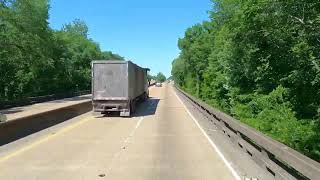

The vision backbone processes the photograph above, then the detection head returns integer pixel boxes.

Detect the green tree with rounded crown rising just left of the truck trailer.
[55,20,102,90]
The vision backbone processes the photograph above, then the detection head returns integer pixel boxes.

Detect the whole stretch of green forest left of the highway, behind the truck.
[0,0,123,102]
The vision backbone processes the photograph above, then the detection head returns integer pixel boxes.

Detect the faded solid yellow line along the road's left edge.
[0,115,92,163]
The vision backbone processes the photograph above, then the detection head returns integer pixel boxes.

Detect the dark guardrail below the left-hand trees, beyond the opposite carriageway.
[0,90,91,109]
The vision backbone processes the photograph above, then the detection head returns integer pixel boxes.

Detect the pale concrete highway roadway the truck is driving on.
[0,84,268,180]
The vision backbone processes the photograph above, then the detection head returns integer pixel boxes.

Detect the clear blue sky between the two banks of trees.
[49,0,212,76]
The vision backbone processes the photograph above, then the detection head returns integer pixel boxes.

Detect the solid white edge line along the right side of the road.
[171,89,241,180]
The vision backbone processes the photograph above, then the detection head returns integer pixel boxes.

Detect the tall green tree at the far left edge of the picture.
[0,0,53,99]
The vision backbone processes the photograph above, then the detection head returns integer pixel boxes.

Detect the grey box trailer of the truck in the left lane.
[92,60,149,116]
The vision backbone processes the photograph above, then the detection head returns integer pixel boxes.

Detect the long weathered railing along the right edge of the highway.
[176,87,320,180]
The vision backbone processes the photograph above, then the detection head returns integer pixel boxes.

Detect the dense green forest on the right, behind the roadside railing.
[172,0,320,161]
